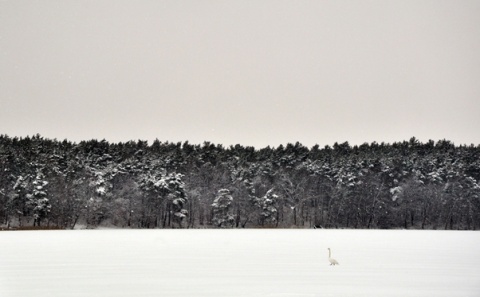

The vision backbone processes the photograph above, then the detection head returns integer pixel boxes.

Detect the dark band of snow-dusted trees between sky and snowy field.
[0,134,480,230]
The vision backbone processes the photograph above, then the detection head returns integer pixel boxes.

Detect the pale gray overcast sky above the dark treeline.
[0,0,480,148]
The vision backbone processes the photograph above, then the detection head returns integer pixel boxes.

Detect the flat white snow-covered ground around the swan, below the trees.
[0,229,480,297]
